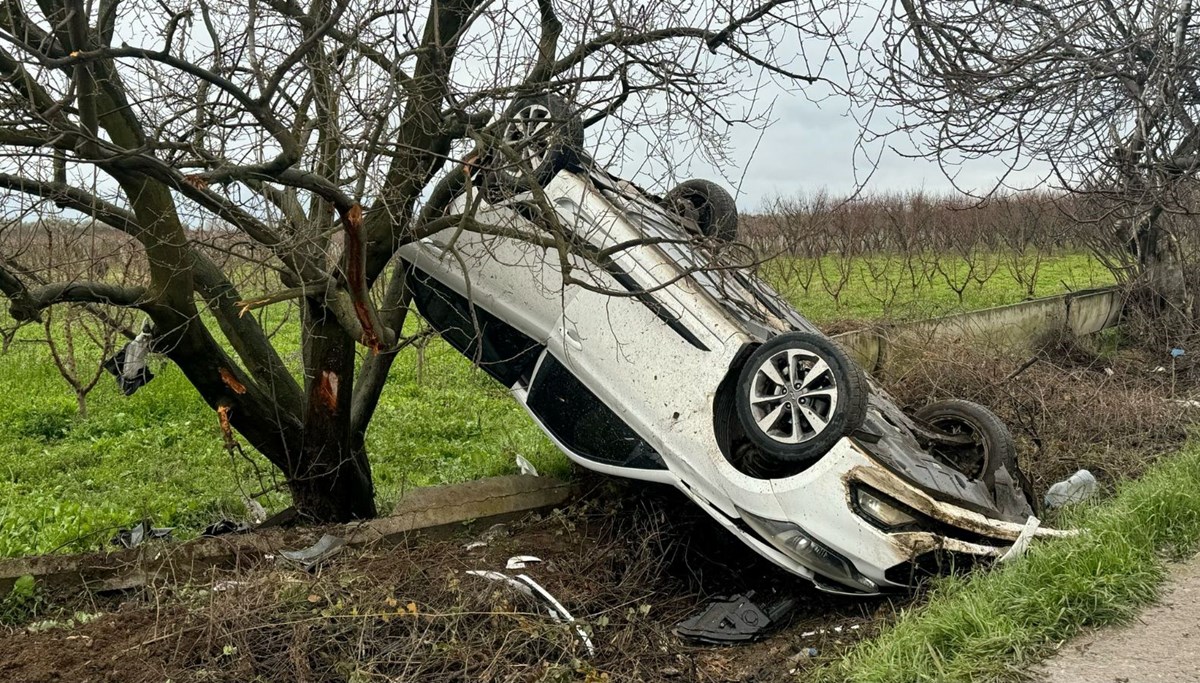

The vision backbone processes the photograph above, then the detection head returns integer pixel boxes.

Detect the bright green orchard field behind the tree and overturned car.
[0,256,1106,556]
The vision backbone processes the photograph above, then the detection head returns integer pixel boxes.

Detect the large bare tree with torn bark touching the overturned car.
[0,0,846,520]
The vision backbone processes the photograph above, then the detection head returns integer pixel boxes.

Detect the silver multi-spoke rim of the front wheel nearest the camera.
[749,349,838,444]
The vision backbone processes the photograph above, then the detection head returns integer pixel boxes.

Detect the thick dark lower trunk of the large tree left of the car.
[288,301,377,522]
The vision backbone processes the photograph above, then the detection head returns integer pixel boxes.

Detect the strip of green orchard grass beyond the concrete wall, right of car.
[763,253,1114,323]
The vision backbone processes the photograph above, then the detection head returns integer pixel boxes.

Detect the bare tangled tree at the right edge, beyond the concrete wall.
[874,0,1200,319]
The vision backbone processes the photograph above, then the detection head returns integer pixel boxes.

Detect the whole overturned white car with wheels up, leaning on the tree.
[401,97,1051,594]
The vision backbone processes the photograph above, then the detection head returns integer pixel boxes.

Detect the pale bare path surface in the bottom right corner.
[1034,557,1200,683]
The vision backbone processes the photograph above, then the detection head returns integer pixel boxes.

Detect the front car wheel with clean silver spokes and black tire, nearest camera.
[737,332,870,472]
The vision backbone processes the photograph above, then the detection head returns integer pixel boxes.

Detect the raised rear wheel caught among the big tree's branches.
[492,94,583,186]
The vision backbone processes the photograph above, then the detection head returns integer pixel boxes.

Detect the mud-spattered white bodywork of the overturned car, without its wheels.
[401,163,1054,594]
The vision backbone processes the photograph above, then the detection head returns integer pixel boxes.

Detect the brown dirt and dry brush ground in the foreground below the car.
[0,480,896,683]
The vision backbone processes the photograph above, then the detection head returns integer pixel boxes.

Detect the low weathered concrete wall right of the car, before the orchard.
[833,287,1124,372]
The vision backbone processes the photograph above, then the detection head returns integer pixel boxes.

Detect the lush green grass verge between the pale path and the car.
[820,442,1200,683]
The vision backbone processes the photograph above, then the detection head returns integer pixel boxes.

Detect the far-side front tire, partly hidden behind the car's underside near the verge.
[913,399,1037,509]
